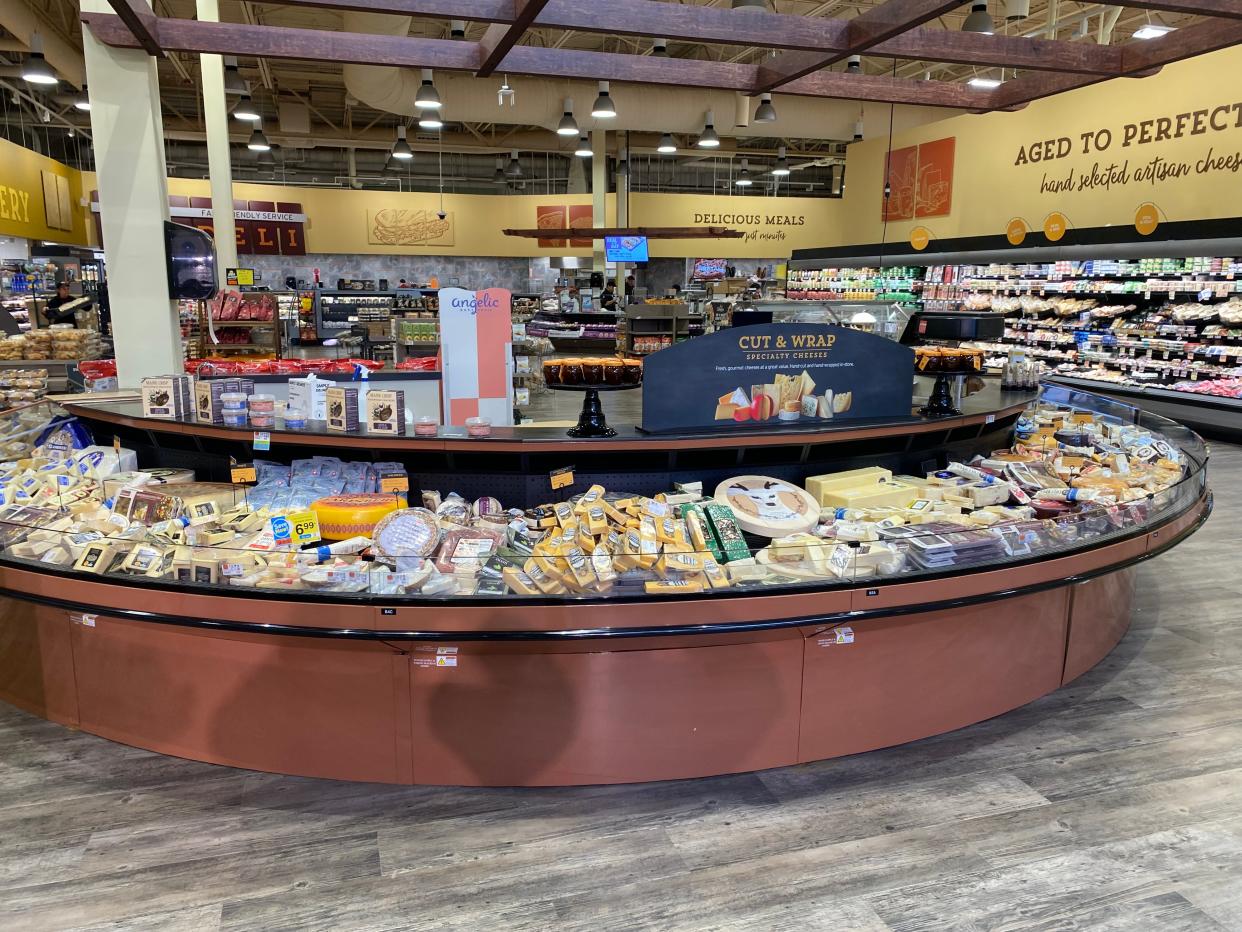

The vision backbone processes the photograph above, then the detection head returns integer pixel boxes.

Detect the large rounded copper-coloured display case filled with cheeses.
[0,386,1211,785]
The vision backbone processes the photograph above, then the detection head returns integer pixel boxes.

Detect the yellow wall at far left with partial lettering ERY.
[0,139,89,246]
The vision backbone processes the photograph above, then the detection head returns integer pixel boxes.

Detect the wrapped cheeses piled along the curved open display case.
[0,405,1187,599]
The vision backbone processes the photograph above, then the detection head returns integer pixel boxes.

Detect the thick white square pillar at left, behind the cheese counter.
[82,0,184,388]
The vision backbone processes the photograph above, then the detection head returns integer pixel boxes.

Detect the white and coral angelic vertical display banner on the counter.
[440,288,513,426]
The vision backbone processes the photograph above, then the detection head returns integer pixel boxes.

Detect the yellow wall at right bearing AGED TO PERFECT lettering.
[821,40,1242,246]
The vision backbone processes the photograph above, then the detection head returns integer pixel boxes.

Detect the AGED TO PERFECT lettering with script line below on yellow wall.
[1013,101,1242,194]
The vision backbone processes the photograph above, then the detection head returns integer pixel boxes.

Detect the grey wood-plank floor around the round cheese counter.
[0,444,1242,932]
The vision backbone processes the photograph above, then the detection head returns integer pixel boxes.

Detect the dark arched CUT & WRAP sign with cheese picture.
[642,323,914,432]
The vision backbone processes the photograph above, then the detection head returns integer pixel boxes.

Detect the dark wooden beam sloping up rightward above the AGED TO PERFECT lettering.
[995,20,1242,107]
